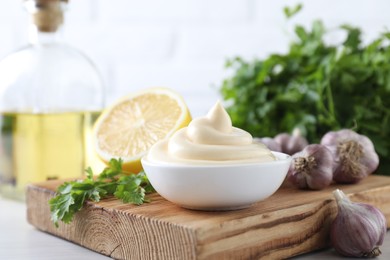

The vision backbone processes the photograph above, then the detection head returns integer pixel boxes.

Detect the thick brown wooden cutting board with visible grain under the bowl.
[27,176,390,260]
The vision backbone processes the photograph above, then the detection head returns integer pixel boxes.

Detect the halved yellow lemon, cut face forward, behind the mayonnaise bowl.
[93,88,191,173]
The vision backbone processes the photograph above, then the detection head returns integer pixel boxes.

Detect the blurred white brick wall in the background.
[0,0,390,116]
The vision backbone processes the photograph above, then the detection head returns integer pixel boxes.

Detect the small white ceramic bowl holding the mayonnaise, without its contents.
[141,152,291,210]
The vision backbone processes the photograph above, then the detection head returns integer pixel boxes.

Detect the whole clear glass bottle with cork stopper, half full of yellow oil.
[0,0,104,199]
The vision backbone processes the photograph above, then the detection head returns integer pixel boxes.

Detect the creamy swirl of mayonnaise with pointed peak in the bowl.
[147,102,275,165]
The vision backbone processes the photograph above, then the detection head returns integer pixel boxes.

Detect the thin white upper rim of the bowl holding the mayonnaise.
[141,151,292,169]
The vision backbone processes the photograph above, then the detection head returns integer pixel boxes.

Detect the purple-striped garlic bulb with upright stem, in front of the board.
[330,189,387,257]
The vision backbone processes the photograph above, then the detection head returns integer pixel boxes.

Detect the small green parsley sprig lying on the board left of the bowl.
[49,159,154,227]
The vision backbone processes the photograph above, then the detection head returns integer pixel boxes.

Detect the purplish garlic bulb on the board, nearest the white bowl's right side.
[287,144,333,190]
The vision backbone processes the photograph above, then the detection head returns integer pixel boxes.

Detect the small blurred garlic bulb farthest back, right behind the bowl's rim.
[274,128,309,155]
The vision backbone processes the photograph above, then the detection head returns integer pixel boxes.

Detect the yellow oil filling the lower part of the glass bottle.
[0,112,101,199]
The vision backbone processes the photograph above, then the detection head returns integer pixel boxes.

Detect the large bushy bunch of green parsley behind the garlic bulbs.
[220,6,390,174]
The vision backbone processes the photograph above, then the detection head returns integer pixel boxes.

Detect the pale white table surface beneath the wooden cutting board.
[0,197,390,260]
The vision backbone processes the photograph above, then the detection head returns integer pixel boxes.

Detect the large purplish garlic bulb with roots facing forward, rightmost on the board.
[321,129,379,183]
